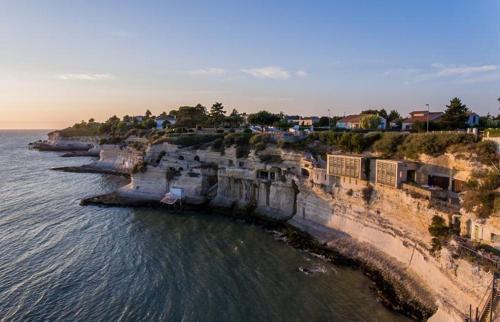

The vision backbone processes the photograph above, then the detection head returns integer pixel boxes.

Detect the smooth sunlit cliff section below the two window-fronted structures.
[292,184,492,321]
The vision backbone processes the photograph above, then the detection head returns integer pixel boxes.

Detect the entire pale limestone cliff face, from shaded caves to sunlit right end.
[92,144,492,321]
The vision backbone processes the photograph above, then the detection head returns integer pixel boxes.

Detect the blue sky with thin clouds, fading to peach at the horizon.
[0,0,500,129]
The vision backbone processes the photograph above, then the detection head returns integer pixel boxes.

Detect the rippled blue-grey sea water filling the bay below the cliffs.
[0,131,408,322]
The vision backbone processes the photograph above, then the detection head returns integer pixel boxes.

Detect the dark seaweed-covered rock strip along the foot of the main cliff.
[80,192,437,321]
